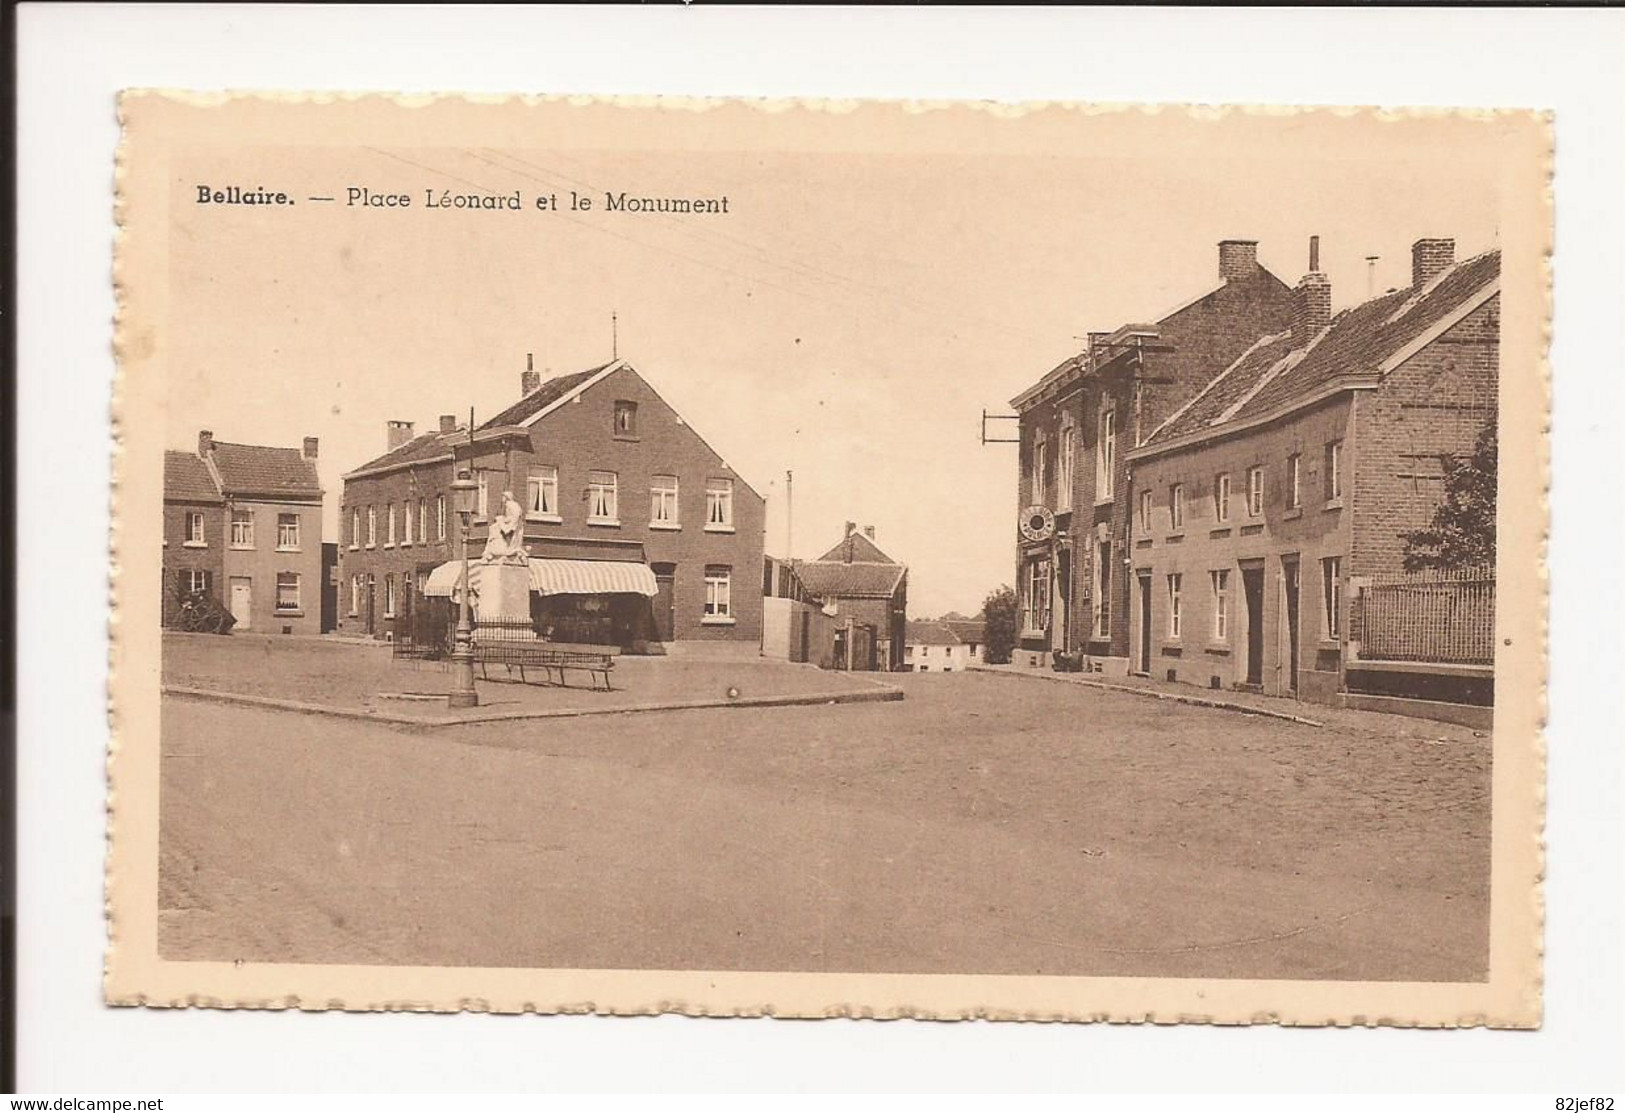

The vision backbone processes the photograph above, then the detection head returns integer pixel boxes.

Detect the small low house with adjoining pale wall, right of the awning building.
[762,522,908,671]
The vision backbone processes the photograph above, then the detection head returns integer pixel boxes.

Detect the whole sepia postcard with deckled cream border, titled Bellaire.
[106,91,1552,1027]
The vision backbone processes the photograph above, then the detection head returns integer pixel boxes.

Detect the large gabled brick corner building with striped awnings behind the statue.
[340,359,767,655]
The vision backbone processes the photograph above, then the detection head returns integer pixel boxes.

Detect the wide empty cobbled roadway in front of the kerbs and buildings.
[159,662,1490,980]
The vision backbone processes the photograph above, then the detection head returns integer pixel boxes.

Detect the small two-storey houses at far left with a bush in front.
[163,431,323,634]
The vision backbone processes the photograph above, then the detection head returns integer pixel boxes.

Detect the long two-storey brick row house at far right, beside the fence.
[1128,239,1500,702]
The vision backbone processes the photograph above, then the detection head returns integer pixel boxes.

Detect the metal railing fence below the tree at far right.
[1355,569,1495,665]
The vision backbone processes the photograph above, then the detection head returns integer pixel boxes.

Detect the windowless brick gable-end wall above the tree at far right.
[1350,296,1500,577]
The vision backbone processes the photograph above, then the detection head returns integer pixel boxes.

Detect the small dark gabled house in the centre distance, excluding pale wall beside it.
[791,522,908,673]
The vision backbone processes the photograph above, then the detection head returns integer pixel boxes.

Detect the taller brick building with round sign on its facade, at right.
[1011,240,1292,669]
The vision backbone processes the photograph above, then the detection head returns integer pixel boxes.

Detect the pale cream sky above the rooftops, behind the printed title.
[164,105,1497,617]
